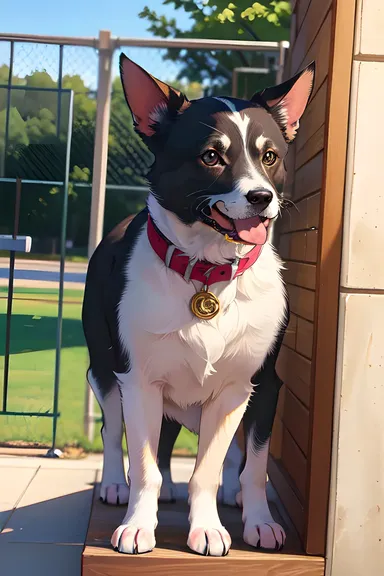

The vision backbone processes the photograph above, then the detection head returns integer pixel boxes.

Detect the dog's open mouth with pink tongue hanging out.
[204,203,270,245]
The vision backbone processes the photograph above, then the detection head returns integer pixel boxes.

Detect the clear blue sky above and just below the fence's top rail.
[0,0,190,88]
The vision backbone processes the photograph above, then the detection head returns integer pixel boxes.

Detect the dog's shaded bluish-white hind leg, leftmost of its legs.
[88,369,129,506]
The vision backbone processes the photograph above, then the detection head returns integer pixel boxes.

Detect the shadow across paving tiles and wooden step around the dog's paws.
[0,483,300,576]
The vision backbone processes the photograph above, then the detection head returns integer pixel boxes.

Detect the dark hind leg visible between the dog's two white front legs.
[157,418,181,502]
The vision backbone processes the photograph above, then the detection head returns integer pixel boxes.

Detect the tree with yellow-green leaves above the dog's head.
[139,0,291,96]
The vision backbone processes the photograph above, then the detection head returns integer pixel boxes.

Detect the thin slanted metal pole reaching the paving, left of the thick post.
[47,91,73,456]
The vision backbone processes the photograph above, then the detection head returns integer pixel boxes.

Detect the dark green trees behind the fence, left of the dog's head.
[0,65,152,250]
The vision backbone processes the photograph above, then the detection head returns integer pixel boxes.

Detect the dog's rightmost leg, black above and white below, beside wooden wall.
[238,302,289,550]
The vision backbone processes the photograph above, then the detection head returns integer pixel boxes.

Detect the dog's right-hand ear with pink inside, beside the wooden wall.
[251,62,315,142]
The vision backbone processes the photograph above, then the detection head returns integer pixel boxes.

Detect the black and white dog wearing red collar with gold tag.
[83,55,314,556]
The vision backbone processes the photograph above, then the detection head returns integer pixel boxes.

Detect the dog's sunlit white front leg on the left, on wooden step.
[111,371,163,554]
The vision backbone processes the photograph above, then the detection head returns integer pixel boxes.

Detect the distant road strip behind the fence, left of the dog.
[0,257,87,288]
